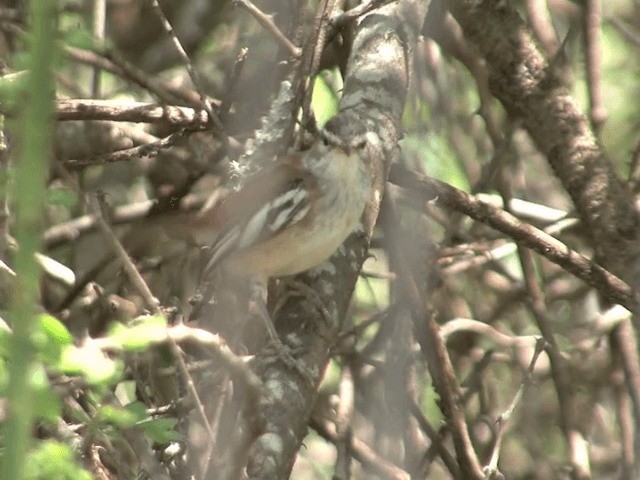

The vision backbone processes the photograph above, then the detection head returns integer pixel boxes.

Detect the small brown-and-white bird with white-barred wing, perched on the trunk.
[184,135,371,281]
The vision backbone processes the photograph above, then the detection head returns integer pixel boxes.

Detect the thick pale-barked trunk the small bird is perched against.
[248,1,427,479]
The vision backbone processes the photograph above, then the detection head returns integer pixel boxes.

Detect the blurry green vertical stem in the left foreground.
[0,1,56,480]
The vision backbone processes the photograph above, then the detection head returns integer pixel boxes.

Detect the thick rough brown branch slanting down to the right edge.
[450,1,640,300]
